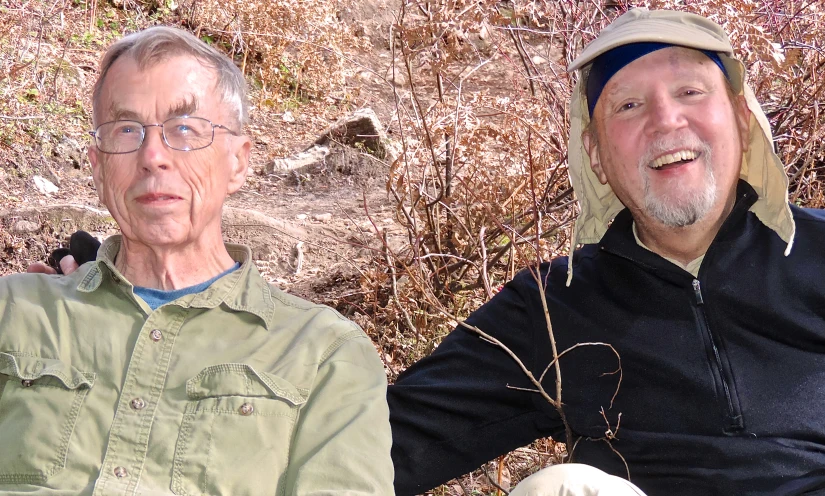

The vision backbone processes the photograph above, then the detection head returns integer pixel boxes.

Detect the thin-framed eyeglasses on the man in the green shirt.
[89,115,238,154]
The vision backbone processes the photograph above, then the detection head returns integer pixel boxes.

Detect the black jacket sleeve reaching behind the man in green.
[387,271,564,496]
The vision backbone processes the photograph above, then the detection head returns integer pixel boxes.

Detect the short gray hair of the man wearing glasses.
[92,26,249,126]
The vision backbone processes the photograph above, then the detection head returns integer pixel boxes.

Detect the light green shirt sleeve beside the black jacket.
[284,329,394,496]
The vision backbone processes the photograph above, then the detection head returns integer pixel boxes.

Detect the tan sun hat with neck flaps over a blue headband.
[567,8,796,285]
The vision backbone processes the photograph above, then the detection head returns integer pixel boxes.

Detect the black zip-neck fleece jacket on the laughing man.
[388,182,825,496]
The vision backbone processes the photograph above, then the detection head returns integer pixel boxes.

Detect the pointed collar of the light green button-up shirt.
[77,235,275,328]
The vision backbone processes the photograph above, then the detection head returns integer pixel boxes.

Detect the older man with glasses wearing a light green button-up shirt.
[0,27,393,496]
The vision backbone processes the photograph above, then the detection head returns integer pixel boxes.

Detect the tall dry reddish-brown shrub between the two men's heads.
[373,0,607,369]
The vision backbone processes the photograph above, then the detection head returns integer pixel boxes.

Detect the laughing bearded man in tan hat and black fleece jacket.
[388,9,825,496]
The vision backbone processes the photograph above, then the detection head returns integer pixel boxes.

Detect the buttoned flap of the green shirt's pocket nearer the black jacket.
[186,363,307,406]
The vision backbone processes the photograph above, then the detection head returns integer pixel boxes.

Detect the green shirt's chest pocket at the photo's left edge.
[0,352,95,485]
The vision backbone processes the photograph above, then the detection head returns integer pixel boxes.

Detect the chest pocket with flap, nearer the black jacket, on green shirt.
[172,363,307,495]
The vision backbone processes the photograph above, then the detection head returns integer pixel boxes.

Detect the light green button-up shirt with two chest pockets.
[0,237,393,496]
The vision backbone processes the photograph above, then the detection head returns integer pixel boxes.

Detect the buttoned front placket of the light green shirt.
[93,305,189,496]
